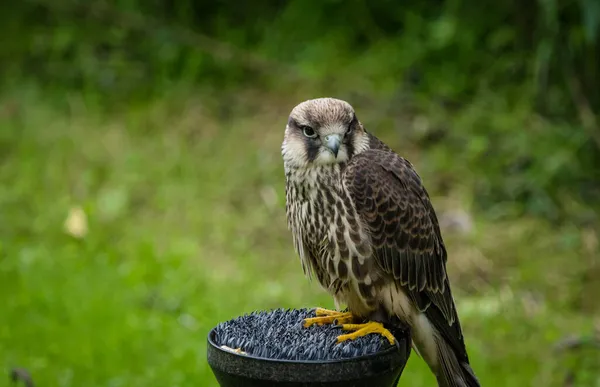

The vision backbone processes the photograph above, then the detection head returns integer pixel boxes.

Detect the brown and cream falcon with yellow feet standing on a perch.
[282,98,479,387]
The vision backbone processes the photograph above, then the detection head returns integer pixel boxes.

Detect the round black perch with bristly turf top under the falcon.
[208,309,410,387]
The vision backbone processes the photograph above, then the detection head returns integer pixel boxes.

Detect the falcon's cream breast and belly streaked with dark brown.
[286,164,380,316]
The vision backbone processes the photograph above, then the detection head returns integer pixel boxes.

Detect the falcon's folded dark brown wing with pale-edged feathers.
[344,149,462,328]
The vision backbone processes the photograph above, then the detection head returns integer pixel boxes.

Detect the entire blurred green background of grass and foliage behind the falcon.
[0,0,600,387]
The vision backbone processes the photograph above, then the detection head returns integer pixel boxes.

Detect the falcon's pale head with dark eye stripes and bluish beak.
[281,98,369,168]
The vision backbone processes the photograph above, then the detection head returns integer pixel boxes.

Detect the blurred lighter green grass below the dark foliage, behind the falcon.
[0,89,598,387]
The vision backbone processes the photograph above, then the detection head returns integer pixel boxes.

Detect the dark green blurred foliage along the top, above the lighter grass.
[0,0,600,224]
